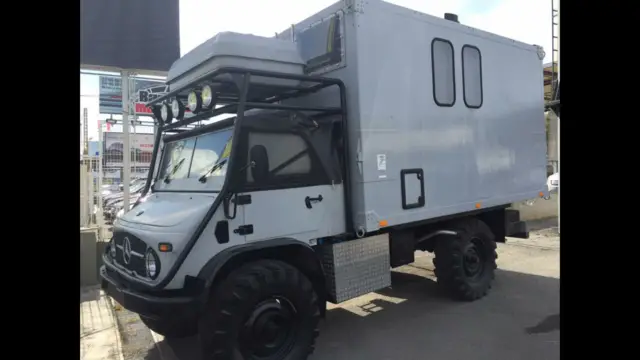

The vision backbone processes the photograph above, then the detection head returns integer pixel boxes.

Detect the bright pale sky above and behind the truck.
[80,0,551,140]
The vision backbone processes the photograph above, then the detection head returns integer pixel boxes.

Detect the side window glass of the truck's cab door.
[247,132,312,185]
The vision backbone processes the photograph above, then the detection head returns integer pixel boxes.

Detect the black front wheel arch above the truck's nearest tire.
[198,238,327,317]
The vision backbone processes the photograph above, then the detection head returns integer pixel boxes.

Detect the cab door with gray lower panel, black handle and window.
[238,131,344,242]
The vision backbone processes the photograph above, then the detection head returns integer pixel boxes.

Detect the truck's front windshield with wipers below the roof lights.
[157,128,233,190]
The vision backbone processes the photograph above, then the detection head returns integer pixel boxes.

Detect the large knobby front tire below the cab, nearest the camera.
[199,260,320,360]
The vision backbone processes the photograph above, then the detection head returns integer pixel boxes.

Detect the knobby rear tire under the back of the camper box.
[433,218,498,301]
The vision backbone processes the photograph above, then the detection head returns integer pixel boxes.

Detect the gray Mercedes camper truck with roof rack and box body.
[101,0,546,360]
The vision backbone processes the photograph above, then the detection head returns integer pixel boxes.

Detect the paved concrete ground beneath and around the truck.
[82,221,560,360]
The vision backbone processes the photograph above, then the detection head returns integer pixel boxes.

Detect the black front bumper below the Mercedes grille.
[100,265,199,318]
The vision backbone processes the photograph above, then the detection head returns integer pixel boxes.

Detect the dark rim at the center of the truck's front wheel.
[239,297,297,360]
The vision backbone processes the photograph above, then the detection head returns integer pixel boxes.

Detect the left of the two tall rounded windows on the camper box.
[431,38,456,106]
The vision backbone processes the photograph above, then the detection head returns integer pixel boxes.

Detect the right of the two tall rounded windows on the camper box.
[462,45,482,109]
